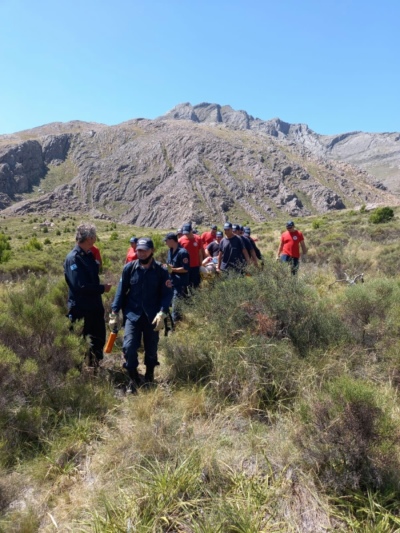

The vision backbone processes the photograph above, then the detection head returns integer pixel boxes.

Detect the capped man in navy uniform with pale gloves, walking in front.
[109,237,172,392]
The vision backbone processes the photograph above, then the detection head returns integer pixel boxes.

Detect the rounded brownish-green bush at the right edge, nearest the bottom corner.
[297,376,400,495]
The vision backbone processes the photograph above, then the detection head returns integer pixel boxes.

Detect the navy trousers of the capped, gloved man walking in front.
[122,314,159,372]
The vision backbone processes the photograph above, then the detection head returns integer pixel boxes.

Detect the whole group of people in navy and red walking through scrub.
[64,221,307,392]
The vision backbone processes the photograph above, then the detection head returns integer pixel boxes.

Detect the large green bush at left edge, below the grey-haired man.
[0,276,112,467]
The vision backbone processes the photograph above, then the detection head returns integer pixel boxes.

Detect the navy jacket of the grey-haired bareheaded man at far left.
[64,245,104,314]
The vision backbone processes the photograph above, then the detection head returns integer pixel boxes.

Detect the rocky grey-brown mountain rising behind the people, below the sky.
[0,104,400,228]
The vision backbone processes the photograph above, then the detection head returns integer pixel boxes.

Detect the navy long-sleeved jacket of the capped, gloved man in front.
[111,259,173,322]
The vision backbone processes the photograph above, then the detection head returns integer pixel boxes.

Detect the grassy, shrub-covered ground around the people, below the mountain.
[0,208,400,533]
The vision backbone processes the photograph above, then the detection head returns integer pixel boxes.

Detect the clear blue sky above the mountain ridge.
[0,0,400,134]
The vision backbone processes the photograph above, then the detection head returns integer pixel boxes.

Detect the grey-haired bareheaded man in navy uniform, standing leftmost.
[64,224,111,367]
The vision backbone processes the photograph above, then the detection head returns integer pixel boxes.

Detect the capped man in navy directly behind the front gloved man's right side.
[164,233,190,322]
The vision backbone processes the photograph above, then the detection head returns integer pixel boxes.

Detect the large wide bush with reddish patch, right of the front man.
[165,260,349,407]
